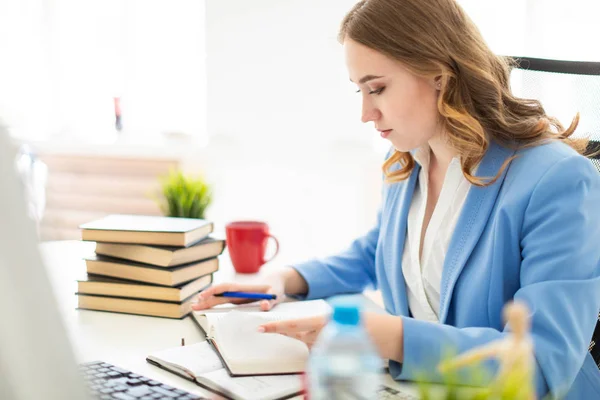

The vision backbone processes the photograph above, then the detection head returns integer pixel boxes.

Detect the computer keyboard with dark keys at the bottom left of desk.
[79,361,209,400]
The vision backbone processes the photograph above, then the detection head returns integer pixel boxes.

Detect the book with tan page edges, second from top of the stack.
[96,237,225,267]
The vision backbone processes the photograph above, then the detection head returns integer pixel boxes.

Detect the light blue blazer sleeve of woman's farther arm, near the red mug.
[293,212,381,299]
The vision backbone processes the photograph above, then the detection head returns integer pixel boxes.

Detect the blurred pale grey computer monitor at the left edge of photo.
[0,121,87,400]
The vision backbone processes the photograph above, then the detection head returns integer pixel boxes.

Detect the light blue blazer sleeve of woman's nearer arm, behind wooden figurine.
[390,156,600,398]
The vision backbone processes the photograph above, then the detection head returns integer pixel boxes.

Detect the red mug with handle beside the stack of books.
[225,221,279,274]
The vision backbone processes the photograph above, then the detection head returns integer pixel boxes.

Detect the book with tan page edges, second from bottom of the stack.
[77,274,213,302]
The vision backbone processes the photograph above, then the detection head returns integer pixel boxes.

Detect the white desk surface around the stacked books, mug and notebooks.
[41,241,415,396]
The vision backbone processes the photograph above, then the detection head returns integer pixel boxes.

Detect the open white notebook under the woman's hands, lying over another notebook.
[192,300,331,376]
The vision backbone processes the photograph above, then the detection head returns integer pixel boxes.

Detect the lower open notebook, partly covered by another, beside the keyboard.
[146,342,302,400]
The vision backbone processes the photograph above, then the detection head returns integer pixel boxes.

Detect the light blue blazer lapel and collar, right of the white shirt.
[439,142,514,323]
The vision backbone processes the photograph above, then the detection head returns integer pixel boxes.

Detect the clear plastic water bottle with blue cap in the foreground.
[306,304,383,400]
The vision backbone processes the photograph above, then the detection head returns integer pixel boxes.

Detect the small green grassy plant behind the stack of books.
[155,169,212,219]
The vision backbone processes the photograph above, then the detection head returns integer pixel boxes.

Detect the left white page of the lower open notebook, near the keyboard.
[148,342,223,376]
